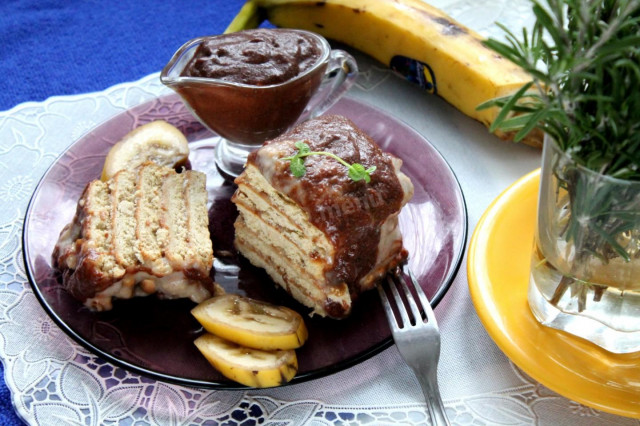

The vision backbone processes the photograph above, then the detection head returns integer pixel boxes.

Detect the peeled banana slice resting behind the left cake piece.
[102,120,189,181]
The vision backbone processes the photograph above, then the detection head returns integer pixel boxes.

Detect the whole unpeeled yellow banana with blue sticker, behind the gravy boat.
[229,0,542,146]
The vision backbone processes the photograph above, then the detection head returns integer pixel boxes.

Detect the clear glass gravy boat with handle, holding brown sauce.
[160,29,358,177]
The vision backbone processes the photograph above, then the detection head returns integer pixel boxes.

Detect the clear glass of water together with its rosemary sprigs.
[478,0,640,353]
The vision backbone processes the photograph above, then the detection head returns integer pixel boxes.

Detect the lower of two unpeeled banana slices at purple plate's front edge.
[194,334,298,388]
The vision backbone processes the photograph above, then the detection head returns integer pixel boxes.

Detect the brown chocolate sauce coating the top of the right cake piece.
[249,116,404,292]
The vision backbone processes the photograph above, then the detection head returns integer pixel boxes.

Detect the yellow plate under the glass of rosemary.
[467,170,640,418]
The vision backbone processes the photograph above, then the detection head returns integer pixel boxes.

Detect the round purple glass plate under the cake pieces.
[23,95,467,389]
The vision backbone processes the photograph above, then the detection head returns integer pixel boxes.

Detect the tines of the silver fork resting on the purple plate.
[378,265,437,329]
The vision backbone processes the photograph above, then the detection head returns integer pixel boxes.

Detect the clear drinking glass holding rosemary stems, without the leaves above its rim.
[529,136,640,353]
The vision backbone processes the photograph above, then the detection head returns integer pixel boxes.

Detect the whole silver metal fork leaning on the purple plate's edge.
[378,265,449,425]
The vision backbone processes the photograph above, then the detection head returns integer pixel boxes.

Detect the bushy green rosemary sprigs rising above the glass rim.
[478,0,640,180]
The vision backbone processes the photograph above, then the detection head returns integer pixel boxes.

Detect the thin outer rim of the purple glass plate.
[21,93,469,390]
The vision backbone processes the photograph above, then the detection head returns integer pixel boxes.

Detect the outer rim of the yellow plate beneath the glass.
[467,168,640,419]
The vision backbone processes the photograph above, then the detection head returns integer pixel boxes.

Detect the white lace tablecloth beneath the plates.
[0,1,640,426]
